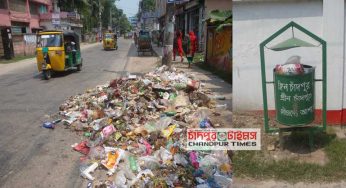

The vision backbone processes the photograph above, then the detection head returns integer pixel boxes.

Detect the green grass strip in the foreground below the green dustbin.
[233,133,346,183]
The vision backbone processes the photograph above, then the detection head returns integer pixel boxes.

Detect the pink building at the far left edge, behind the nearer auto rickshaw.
[0,0,51,58]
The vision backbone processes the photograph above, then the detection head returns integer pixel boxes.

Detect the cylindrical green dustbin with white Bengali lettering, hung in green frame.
[274,65,315,126]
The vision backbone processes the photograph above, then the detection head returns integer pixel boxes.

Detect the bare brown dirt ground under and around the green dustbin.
[233,112,328,166]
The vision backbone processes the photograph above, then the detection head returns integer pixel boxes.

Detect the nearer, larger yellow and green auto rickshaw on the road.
[36,31,83,80]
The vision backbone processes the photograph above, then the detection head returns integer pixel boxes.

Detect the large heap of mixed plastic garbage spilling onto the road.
[56,66,232,188]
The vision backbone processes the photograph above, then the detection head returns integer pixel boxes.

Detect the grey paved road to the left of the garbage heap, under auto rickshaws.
[0,39,134,188]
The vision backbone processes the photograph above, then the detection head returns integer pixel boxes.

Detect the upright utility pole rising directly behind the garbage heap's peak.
[162,3,175,68]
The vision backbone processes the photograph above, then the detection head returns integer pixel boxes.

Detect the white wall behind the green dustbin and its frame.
[233,0,346,123]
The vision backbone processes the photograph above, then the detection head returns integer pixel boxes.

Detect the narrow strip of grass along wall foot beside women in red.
[193,53,232,84]
